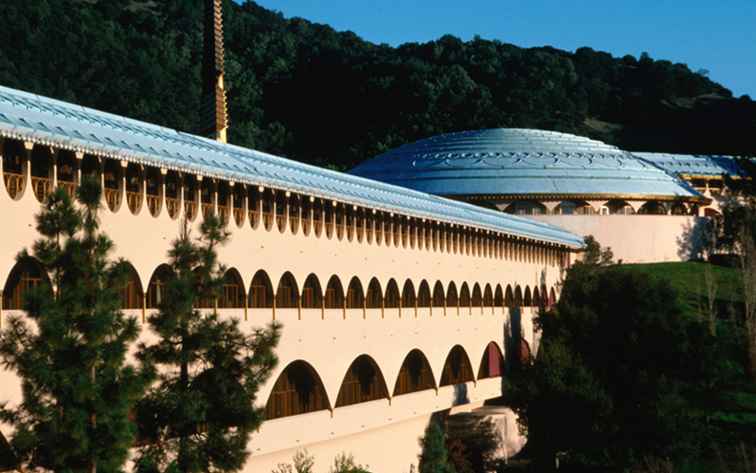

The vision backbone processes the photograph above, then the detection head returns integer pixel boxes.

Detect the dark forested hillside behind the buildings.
[0,0,756,168]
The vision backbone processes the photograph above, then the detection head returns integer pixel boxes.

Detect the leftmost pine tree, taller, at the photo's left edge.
[0,180,151,473]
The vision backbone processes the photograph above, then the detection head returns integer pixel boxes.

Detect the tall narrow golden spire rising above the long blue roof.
[200,0,228,143]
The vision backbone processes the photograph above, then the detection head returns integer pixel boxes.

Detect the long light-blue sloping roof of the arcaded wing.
[0,86,582,247]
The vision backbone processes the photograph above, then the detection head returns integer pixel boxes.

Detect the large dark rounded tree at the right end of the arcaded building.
[504,263,743,471]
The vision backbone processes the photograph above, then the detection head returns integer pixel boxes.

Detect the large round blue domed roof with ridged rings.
[351,128,701,199]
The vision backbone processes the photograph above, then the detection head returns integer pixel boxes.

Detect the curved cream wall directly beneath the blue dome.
[529,215,702,263]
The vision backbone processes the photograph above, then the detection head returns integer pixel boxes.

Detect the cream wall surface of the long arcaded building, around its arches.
[0,163,560,472]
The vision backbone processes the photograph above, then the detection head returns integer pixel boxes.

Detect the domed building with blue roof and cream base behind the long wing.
[351,129,738,262]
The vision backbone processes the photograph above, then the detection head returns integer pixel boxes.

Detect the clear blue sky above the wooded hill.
[250,0,756,99]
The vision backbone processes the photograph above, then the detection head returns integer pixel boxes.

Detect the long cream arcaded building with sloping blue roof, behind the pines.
[0,87,582,471]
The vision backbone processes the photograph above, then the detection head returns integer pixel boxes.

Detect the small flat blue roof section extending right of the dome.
[633,151,742,176]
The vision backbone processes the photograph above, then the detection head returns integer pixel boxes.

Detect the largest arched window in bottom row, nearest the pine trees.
[265,360,331,420]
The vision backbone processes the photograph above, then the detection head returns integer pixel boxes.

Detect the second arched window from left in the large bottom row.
[336,355,388,407]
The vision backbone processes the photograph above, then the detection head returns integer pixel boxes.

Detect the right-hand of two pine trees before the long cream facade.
[137,217,280,473]
